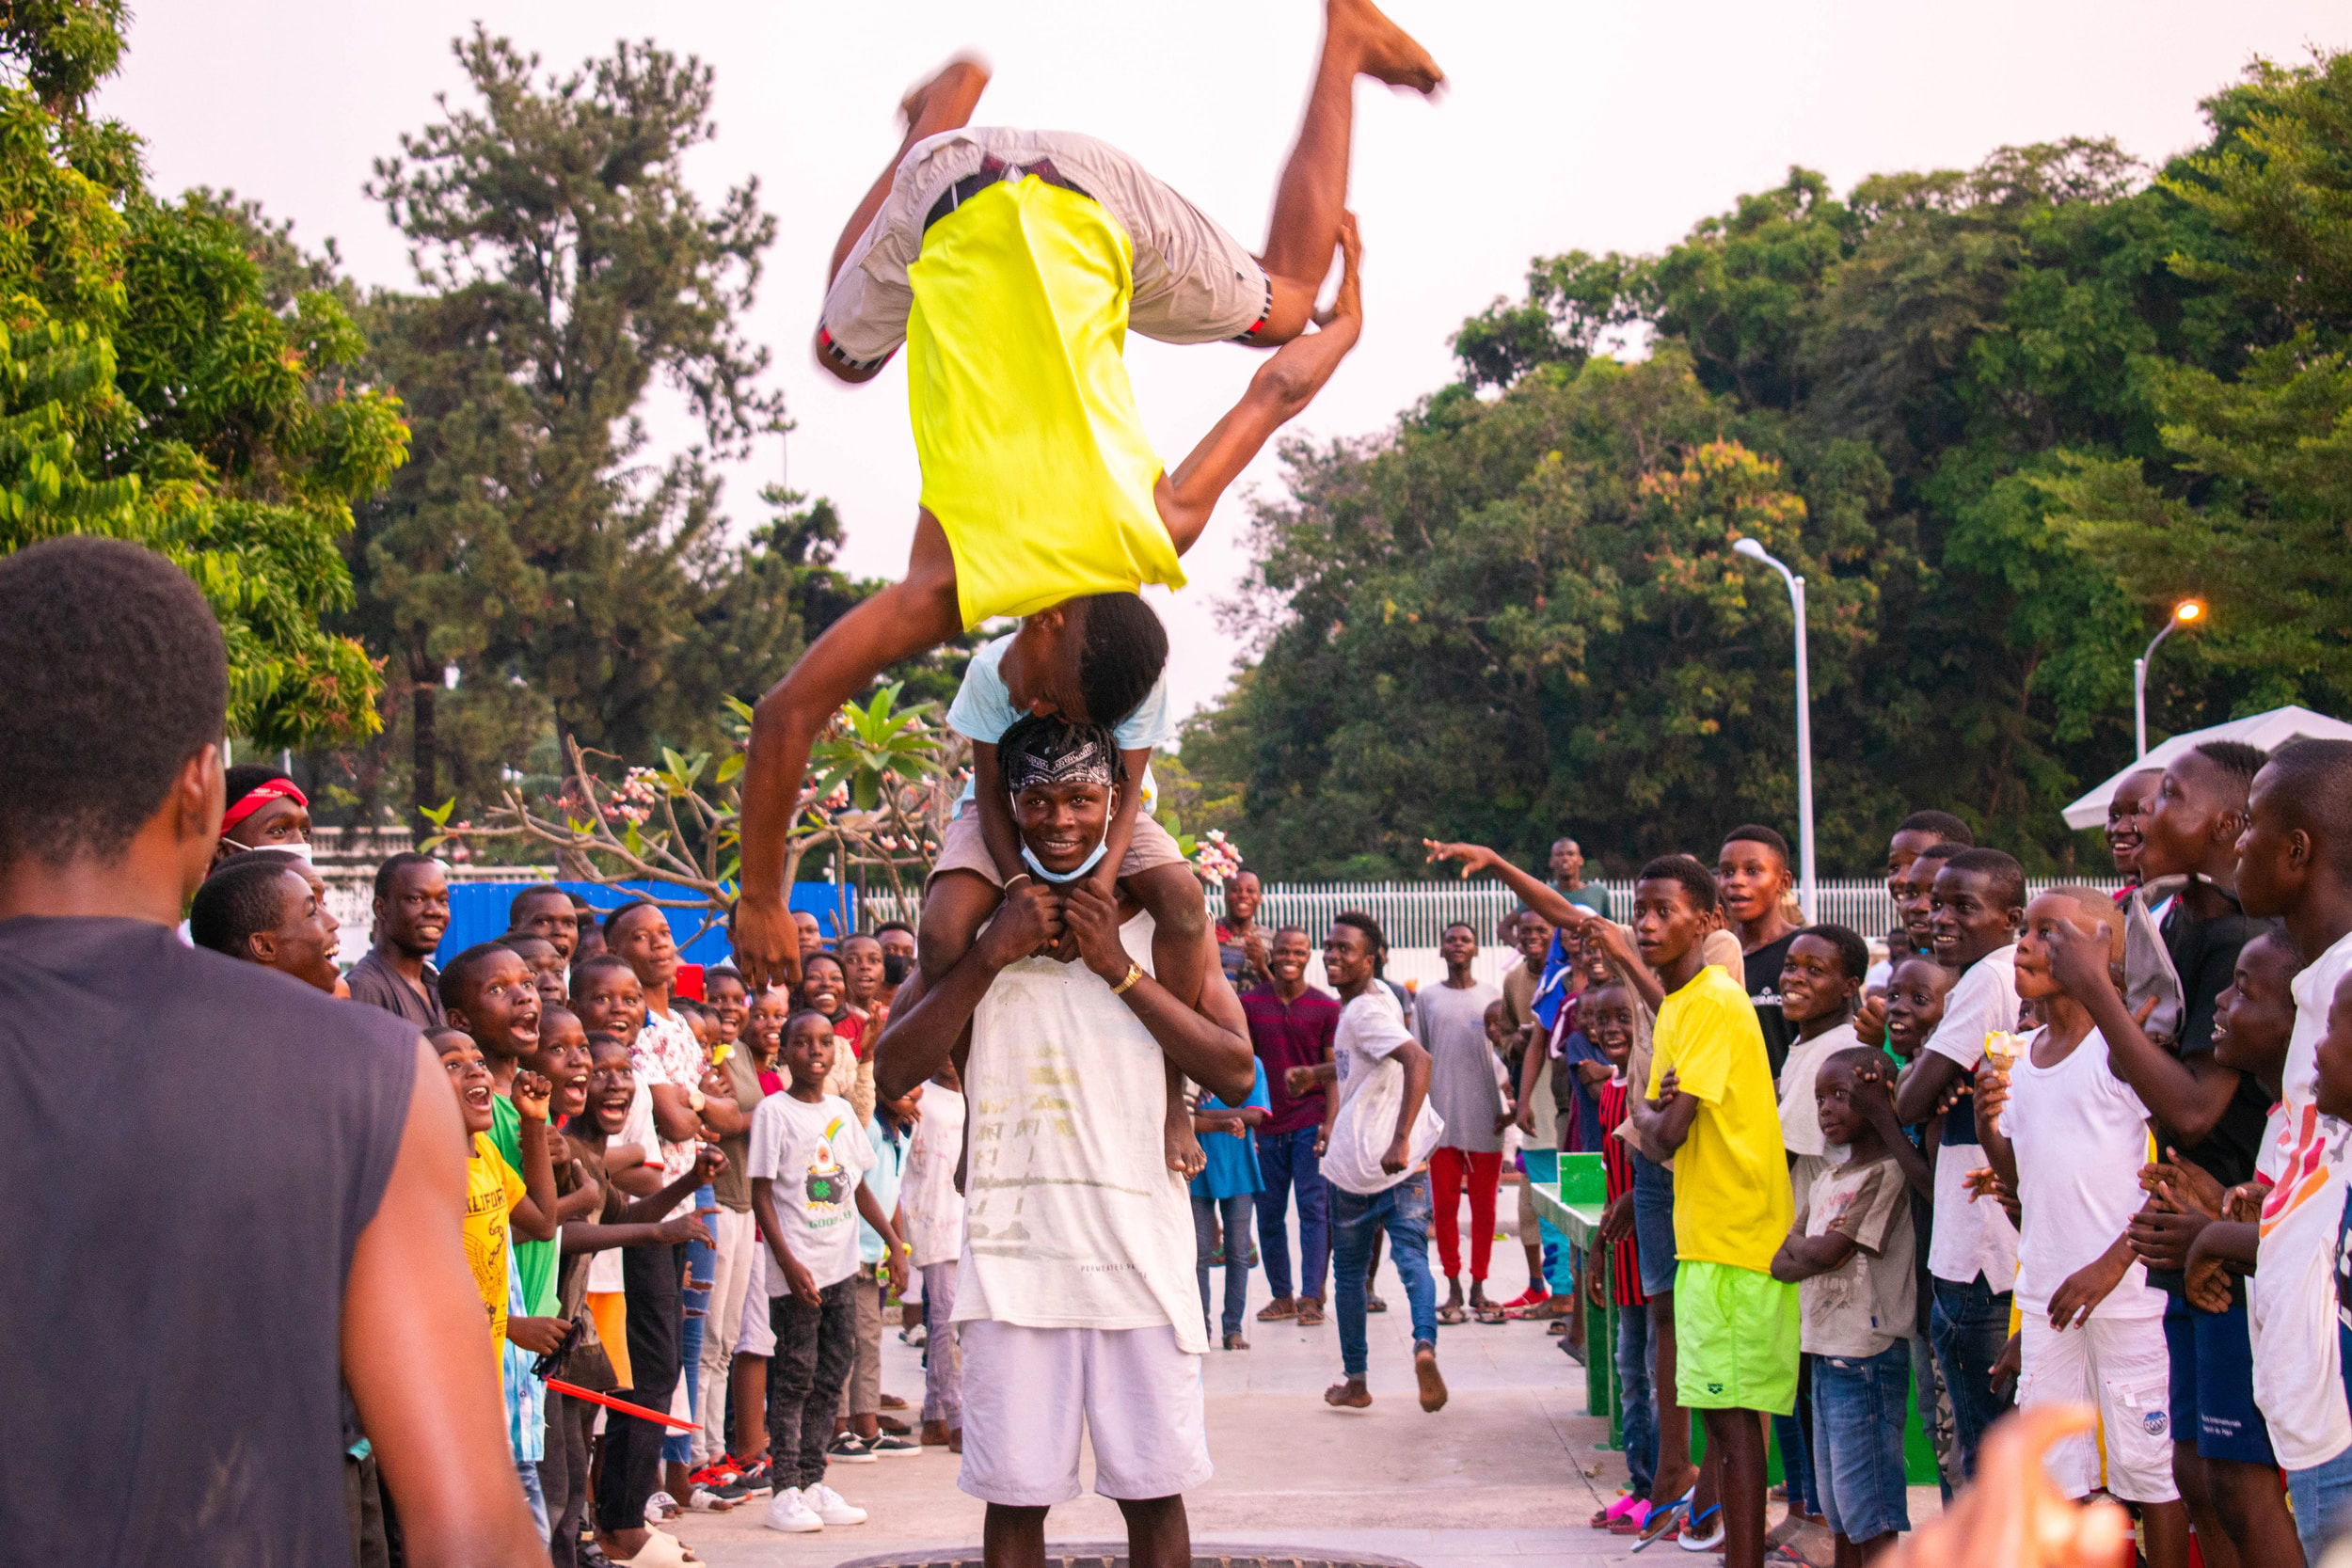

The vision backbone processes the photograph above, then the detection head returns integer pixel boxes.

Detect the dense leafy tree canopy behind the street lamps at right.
[1185,54,2352,875]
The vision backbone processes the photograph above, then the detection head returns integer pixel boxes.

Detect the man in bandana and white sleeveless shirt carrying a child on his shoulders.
[875,717,1256,1563]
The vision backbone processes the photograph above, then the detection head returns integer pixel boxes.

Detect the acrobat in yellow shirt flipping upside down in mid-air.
[734,0,1442,985]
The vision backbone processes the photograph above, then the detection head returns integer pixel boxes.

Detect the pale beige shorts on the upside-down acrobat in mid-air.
[821,127,1275,364]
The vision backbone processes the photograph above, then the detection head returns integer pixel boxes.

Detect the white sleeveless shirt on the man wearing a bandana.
[955,914,1209,1354]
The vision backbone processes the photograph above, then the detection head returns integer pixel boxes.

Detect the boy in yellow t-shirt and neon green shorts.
[1630,856,1797,1568]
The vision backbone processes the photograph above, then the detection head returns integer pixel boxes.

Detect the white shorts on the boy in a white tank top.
[2018,1307,2181,1502]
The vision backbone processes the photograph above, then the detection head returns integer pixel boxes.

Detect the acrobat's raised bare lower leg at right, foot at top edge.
[1251,0,1444,345]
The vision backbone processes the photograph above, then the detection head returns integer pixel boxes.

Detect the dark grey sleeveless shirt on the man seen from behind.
[0,917,417,1568]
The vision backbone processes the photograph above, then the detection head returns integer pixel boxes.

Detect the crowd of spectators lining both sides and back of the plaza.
[174,714,2352,1568]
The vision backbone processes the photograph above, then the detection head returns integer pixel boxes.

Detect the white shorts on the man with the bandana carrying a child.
[955,1319,1216,1510]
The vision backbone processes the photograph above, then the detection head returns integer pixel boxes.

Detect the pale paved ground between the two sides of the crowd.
[673,1190,1936,1568]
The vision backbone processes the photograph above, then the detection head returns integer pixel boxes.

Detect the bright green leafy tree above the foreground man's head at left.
[0,0,407,745]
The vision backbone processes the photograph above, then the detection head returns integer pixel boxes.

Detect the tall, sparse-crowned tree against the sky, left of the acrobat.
[351,30,803,804]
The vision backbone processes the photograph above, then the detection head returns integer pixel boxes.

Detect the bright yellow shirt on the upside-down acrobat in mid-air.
[906,174,1184,627]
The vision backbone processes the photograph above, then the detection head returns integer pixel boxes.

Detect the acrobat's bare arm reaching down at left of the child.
[734,513,964,990]
